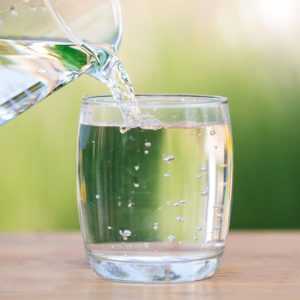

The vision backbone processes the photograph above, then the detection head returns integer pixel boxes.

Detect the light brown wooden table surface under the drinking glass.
[0,231,300,300]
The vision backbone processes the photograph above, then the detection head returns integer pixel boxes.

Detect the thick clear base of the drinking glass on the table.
[88,253,221,283]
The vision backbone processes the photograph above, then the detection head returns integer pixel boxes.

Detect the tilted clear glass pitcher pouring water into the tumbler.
[0,0,122,125]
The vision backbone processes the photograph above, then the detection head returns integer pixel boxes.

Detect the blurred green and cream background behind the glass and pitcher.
[0,0,300,231]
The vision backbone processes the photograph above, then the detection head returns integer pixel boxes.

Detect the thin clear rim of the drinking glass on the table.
[82,94,228,108]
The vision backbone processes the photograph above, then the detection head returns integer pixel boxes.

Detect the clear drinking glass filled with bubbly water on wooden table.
[77,95,233,283]
